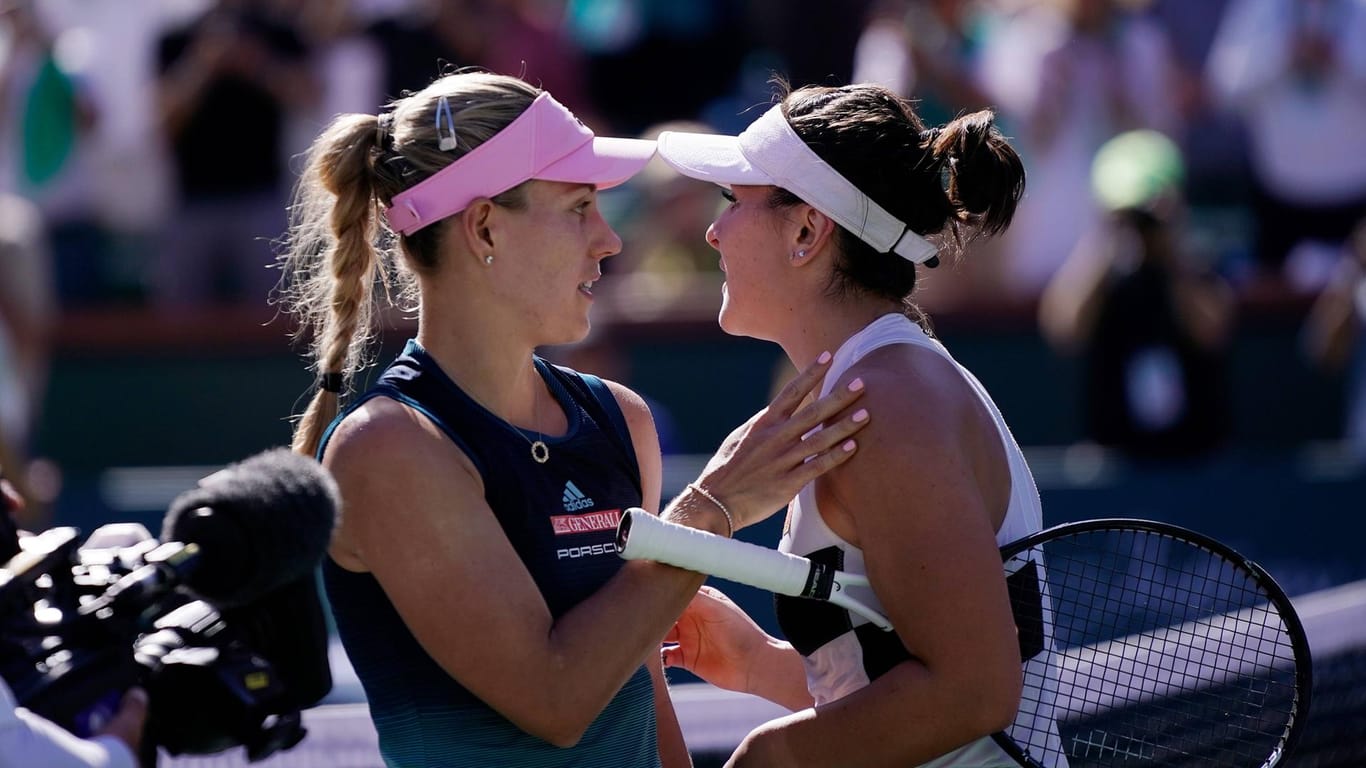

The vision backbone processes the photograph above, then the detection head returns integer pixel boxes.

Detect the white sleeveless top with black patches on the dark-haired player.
[777,314,1065,768]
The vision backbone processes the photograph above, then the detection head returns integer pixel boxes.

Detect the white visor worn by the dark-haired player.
[658,105,938,264]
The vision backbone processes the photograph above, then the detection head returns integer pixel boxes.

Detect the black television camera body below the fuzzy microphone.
[0,525,314,761]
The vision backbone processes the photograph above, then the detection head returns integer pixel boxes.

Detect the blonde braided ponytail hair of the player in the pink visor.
[277,71,541,455]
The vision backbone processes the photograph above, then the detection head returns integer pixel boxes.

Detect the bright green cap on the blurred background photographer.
[1091,130,1186,210]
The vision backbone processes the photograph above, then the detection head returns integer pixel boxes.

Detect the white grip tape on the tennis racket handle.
[616,507,811,597]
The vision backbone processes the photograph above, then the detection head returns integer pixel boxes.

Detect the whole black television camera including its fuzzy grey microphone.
[0,448,339,764]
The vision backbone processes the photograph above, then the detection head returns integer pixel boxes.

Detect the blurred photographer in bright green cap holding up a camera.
[1040,131,1233,459]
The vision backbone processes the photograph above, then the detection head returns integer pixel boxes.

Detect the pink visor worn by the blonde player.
[385,92,654,235]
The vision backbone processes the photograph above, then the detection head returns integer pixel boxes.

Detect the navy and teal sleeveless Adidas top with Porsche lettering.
[318,340,660,768]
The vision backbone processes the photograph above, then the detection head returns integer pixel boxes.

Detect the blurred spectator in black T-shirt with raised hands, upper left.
[152,0,317,309]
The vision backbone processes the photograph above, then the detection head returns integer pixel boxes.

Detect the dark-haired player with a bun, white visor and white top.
[619,85,1065,768]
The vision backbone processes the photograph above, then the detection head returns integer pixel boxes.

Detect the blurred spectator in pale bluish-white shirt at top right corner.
[1208,0,1366,290]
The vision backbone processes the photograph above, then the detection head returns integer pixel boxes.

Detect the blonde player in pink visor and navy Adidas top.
[283,72,867,768]
